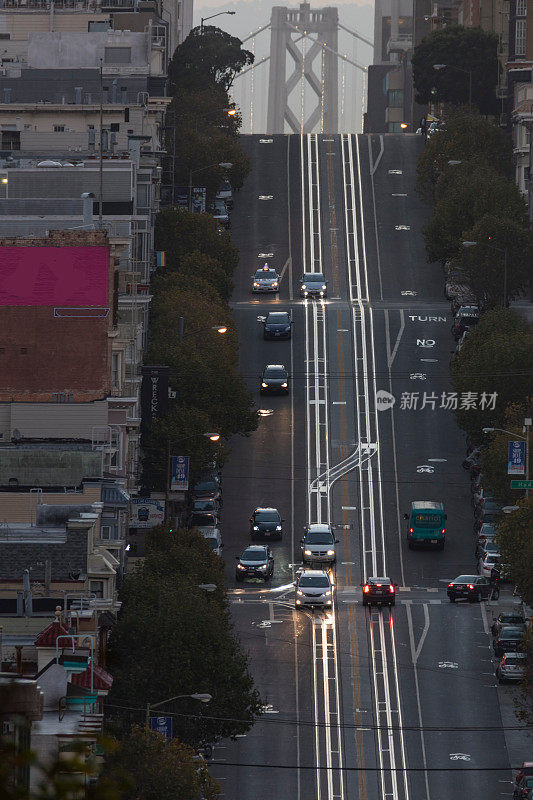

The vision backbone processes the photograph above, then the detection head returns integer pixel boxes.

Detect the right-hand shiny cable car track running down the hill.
[341,134,409,800]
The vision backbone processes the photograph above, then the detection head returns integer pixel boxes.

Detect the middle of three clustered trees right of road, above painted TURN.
[424,162,528,261]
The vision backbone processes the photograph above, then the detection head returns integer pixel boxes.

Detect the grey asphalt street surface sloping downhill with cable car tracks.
[212,135,512,800]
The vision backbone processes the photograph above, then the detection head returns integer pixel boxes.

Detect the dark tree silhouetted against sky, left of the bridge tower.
[168,25,254,94]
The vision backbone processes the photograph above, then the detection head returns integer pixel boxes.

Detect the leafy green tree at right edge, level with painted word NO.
[450,309,533,442]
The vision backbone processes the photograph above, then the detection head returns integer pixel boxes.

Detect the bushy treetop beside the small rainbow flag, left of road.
[155,209,239,275]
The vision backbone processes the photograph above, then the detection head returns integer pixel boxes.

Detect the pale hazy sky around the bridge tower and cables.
[194,0,374,133]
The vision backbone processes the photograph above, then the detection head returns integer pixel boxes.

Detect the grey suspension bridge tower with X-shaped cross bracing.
[267,3,339,133]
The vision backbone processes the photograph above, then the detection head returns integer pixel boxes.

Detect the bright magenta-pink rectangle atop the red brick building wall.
[0,247,109,307]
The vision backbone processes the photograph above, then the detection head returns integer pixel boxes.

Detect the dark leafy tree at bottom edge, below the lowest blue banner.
[102,726,220,800]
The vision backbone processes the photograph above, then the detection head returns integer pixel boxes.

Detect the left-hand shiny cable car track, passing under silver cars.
[300,134,344,800]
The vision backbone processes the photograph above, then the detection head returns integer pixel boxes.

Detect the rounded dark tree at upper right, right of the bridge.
[412,25,498,114]
